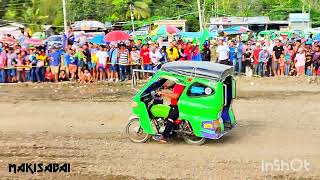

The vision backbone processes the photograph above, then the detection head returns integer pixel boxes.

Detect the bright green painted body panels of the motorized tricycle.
[133,70,235,137]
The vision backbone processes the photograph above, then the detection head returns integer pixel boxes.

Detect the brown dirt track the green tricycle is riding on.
[0,78,320,179]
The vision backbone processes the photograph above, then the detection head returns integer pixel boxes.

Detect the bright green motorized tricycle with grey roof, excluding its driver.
[126,61,237,145]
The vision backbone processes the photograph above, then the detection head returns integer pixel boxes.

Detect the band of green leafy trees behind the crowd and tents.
[0,0,320,31]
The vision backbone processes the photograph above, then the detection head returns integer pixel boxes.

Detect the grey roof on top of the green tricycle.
[161,61,234,81]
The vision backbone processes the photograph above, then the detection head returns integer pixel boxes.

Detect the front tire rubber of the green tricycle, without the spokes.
[126,118,151,143]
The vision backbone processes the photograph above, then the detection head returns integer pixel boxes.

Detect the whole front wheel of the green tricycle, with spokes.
[126,118,150,143]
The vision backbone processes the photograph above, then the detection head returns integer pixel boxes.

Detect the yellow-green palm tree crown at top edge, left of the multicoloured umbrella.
[126,0,152,20]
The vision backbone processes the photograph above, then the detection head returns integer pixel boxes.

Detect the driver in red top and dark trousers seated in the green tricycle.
[153,81,185,143]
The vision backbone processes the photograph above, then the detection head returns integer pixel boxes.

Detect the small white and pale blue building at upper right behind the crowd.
[288,13,311,30]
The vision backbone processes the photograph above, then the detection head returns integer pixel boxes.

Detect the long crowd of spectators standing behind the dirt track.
[0,32,320,83]
